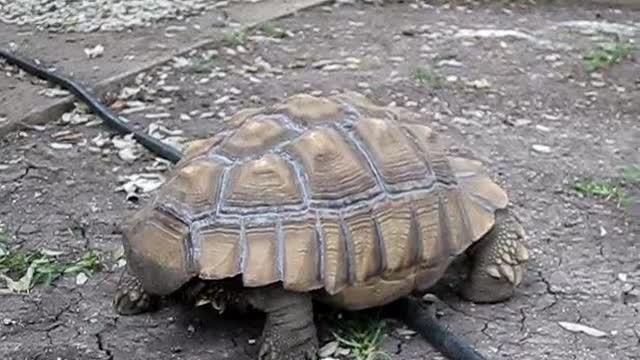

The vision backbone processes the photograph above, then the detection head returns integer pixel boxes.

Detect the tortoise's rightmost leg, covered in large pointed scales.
[461,210,529,303]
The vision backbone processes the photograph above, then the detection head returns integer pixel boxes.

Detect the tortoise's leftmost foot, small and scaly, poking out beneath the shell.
[113,271,155,315]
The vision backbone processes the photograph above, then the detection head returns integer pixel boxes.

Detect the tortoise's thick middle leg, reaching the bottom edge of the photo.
[247,286,318,360]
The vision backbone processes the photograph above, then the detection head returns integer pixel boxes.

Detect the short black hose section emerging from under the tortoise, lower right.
[393,297,487,360]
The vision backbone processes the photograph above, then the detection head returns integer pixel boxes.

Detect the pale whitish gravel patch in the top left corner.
[0,0,261,32]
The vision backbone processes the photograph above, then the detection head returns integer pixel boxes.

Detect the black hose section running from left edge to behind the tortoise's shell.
[0,49,182,163]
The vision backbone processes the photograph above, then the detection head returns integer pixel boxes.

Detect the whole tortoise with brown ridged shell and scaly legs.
[113,90,529,360]
